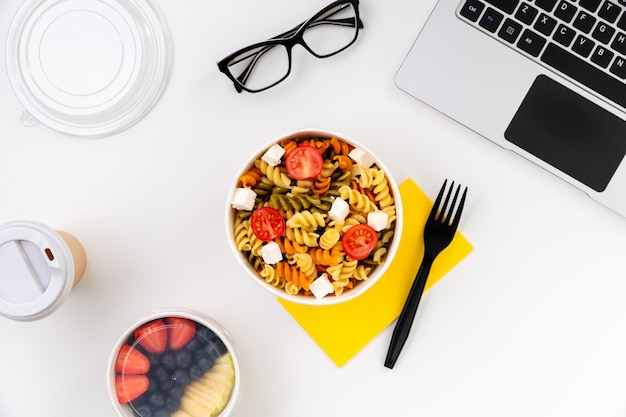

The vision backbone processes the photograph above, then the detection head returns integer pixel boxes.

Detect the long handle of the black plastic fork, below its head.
[385,258,433,369]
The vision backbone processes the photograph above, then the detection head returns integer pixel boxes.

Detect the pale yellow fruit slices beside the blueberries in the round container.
[179,353,235,417]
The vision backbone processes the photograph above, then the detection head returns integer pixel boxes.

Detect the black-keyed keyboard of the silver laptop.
[458,0,626,109]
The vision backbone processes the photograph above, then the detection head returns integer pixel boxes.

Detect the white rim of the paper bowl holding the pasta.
[226,128,403,306]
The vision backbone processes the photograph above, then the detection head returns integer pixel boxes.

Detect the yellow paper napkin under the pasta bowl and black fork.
[278,179,472,367]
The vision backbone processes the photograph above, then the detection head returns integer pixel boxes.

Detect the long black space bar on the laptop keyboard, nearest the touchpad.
[541,43,626,108]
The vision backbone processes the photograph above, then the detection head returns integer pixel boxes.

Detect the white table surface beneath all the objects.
[0,0,626,417]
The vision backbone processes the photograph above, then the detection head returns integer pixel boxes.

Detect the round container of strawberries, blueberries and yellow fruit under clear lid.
[107,308,241,417]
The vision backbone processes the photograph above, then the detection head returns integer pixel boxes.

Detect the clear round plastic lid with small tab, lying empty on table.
[6,0,172,137]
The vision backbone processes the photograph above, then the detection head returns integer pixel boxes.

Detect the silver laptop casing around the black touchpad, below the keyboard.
[395,0,626,216]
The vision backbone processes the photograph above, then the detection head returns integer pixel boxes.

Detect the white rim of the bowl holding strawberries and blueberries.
[107,307,241,417]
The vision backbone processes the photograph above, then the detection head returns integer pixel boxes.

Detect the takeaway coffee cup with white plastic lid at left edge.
[0,221,86,321]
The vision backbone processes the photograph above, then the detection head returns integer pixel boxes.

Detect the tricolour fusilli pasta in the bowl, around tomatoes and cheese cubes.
[232,136,397,296]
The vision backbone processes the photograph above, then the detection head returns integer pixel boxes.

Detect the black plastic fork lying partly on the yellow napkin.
[385,180,467,369]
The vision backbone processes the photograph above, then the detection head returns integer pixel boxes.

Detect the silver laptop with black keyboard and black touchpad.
[395,0,626,216]
